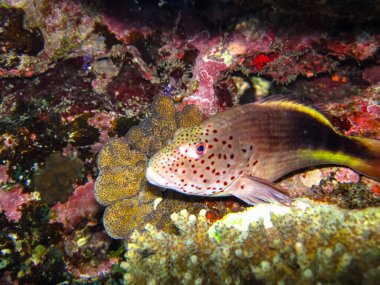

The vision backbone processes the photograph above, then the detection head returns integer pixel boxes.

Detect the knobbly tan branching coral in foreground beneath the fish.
[124,199,380,284]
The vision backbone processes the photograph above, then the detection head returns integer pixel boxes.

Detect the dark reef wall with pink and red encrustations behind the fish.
[0,0,380,284]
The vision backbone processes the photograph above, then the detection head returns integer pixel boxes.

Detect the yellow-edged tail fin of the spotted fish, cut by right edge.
[347,137,380,181]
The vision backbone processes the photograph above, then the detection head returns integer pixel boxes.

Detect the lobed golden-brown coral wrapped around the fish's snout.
[95,96,206,239]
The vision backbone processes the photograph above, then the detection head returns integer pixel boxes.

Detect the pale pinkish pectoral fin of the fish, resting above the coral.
[233,175,292,206]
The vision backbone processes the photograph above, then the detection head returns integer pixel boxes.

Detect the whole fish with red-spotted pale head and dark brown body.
[146,97,380,206]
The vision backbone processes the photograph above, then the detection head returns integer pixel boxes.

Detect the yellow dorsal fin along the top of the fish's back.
[254,95,334,129]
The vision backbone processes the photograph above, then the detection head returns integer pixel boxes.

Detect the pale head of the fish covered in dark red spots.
[146,123,252,196]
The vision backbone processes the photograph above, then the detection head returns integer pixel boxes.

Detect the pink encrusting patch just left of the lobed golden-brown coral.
[51,177,99,228]
